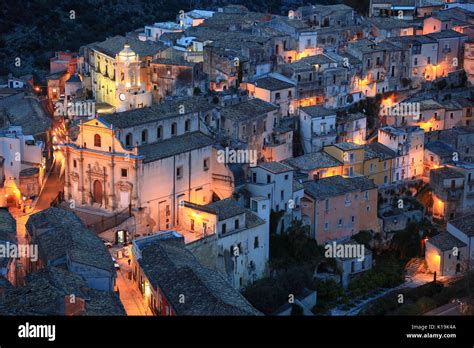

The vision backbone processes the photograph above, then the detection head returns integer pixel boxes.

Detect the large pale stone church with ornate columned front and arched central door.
[64,106,218,232]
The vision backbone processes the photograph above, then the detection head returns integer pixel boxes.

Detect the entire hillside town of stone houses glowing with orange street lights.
[0,0,474,316]
